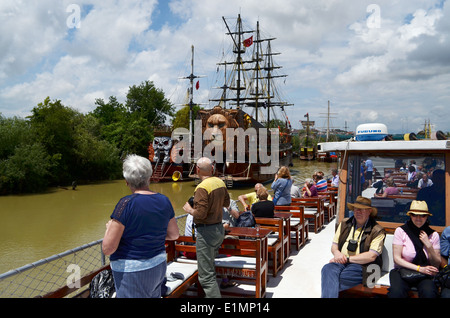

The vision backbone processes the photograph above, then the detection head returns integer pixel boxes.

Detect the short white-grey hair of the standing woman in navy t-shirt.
[123,155,153,189]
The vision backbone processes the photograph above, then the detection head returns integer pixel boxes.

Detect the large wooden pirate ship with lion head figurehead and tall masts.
[189,15,292,187]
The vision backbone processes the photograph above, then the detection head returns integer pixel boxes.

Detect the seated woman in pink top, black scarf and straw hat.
[388,201,440,298]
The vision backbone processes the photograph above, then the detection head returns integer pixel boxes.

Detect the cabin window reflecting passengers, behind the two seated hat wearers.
[345,154,446,226]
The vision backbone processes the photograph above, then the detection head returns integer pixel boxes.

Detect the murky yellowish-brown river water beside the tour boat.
[0,159,336,273]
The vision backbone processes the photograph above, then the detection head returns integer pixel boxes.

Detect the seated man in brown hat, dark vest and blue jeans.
[322,196,386,298]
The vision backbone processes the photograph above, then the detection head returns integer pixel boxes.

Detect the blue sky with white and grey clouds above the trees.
[0,0,450,133]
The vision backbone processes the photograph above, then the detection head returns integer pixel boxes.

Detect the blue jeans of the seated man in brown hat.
[322,263,362,298]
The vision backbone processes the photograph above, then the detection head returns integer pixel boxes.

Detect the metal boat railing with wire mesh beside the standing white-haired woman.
[0,214,187,298]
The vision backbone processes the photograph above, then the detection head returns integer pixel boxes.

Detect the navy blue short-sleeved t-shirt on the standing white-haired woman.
[110,193,175,261]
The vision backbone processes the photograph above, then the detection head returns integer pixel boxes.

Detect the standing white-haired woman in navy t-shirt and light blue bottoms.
[102,155,179,298]
